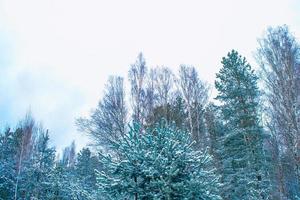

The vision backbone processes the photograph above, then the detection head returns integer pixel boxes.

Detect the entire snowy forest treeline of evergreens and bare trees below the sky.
[0,26,300,200]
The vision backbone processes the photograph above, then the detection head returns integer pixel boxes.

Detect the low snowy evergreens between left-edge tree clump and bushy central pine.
[48,143,100,200]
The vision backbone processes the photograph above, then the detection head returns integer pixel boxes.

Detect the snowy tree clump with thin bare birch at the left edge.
[0,115,55,199]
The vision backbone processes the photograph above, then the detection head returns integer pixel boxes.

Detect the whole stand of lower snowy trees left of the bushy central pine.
[0,116,100,200]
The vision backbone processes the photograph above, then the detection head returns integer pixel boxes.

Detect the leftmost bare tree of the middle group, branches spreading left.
[77,76,127,149]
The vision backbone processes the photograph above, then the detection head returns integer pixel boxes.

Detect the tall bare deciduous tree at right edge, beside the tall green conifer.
[257,26,300,198]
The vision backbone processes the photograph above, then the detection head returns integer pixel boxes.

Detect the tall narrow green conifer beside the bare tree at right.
[215,50,269,200]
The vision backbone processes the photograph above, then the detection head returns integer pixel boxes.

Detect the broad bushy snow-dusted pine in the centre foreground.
[97,122,221,200]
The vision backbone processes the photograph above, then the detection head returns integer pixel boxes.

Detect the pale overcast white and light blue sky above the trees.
[0,0,300,152]
